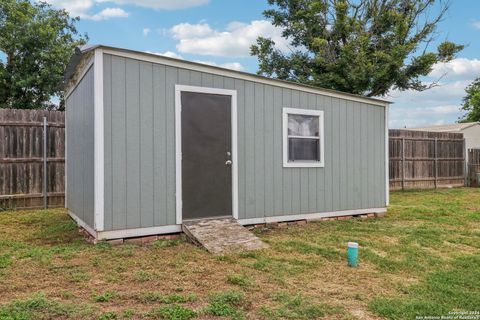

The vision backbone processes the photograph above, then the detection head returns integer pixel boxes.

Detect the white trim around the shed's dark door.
[175,84,238,224]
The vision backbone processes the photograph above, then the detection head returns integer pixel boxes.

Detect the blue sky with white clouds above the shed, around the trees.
[43,0,480,128]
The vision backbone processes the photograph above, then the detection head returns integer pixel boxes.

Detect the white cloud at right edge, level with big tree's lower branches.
[429,58,480,79]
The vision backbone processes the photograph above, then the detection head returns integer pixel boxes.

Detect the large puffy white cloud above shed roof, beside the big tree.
[170,20,288,57]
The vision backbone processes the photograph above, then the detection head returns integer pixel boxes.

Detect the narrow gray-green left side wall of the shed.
[66,67,94,228]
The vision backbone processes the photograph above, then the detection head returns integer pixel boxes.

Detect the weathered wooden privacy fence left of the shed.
[0,109,65,209]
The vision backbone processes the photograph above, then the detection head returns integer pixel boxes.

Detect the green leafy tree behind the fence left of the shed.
[0,0,87,109]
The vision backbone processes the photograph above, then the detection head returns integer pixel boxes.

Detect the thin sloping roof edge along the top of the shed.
[62,45,392,106]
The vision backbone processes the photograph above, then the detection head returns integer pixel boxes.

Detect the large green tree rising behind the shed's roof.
[251,0,463,96]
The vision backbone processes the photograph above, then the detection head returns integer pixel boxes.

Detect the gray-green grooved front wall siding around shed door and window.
[104,55,385,229]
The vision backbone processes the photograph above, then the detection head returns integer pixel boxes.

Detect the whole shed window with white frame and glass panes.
[283,108,323,167]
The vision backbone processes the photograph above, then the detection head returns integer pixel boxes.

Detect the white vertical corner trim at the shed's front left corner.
[93,49,105,231]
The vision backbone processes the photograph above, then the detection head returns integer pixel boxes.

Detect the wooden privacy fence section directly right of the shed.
[389,130,465,190]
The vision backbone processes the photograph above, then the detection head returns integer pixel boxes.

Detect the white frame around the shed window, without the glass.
[283,108,325,168]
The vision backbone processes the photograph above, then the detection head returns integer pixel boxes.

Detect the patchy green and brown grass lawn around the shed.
[0,189,480,320]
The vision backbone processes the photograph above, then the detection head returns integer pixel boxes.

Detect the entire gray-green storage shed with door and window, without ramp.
[65,46,389,239]
